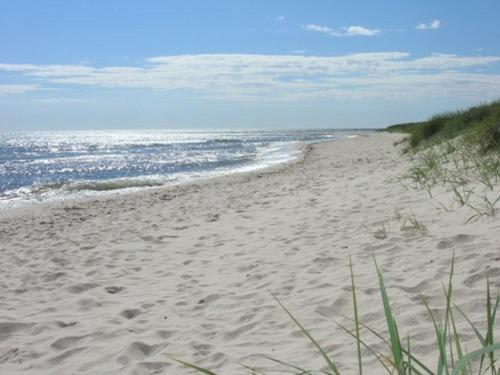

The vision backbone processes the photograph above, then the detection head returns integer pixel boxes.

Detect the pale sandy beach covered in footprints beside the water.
[0,133,500,374]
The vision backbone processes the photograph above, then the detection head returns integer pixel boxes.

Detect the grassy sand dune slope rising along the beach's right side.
[385,101,500,223]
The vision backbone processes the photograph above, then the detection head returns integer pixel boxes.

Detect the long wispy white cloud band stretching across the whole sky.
[0,52,500,101]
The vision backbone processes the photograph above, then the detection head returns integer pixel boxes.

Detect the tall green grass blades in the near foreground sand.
[169,256,500,375]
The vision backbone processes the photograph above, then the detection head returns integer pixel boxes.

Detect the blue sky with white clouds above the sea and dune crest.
[0,0,500,131]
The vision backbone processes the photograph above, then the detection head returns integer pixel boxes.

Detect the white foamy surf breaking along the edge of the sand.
[0,129,366,211]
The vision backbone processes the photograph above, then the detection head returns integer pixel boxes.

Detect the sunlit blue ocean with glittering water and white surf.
[0,129,356,209]
